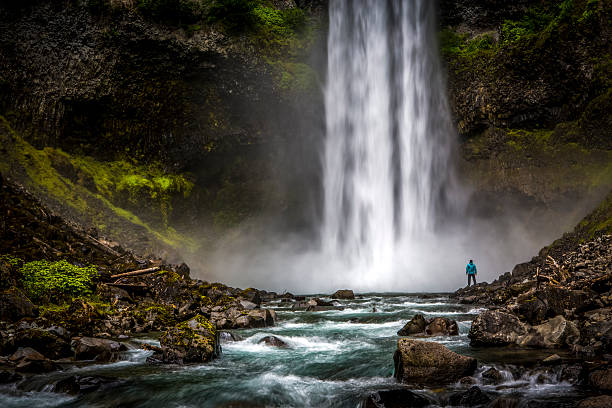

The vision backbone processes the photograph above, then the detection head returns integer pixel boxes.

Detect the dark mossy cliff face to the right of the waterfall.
[441,0,612,217]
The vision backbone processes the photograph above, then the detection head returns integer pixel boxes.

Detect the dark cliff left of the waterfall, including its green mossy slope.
[0,0,322,258]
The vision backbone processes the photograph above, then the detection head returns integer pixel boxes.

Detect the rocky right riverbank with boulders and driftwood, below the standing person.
[444,235,612,407]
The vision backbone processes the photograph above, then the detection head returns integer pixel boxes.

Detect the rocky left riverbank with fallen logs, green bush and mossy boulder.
[0,177,286,383]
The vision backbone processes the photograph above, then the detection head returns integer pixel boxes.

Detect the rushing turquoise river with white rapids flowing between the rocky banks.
[0,294,579,408]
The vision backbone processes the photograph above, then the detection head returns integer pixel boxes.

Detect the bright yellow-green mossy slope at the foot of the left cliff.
[0,116,195,249]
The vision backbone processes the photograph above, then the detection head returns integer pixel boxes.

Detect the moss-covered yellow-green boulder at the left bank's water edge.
[160,315,221,364]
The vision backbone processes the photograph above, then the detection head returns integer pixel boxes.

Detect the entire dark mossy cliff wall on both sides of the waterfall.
[0,0,612,262]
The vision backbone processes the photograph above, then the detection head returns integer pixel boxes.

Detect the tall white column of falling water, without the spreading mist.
[321,0,454,289]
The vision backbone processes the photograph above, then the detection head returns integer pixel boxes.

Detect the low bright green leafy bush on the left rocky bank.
[20,260,97,303]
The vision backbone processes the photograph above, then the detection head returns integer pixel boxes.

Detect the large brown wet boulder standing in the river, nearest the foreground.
[393,338,477,385]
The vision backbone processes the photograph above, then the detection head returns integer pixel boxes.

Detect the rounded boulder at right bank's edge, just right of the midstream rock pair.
[468,310,527,346]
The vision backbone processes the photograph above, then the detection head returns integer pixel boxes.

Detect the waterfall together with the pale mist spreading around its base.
[191,0,584,293]
